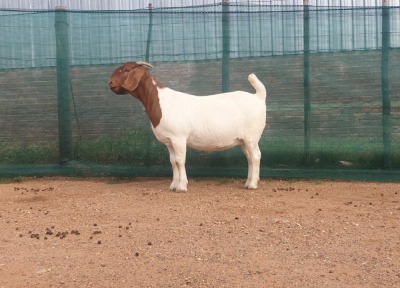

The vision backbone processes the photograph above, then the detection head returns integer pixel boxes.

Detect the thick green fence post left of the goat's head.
[55,6,73,164]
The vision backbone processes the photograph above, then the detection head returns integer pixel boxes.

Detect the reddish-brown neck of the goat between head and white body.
[132,74,163,128]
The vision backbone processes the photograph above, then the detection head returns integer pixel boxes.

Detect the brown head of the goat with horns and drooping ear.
[109,62,152,95]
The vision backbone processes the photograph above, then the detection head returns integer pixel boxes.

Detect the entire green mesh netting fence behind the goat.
[0,3,400,180]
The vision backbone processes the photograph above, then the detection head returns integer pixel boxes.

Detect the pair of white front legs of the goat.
[167,140,188,192]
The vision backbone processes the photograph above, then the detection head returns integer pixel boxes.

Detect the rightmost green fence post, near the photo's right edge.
[381,0,392,169]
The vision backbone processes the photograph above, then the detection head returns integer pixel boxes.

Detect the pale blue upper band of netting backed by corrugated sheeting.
[0,5,400,69]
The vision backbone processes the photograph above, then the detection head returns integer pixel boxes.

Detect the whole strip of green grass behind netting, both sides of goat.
[0,131,400,169]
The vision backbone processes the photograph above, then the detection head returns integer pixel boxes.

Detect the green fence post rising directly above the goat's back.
[222,0,231,92]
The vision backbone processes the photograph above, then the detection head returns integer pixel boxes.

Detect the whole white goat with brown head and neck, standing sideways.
[110,62,266,191]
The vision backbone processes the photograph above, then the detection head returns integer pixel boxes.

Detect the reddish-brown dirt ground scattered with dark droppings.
[0,178,400,287]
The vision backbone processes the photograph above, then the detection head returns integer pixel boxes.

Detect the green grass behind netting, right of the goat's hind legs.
[262,137,394,169]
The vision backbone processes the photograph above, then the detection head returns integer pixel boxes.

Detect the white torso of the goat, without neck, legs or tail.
[152,88,266,151]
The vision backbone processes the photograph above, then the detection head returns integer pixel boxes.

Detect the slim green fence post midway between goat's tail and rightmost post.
[303,0,311,165]
